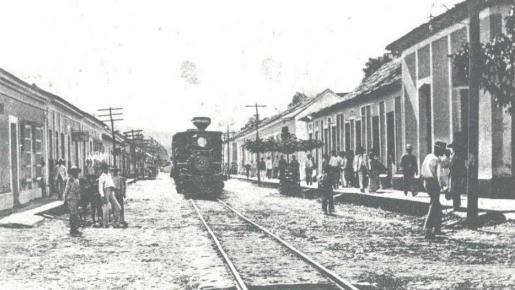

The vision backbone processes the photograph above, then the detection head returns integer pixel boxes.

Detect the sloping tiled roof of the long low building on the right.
[311,59,402,118]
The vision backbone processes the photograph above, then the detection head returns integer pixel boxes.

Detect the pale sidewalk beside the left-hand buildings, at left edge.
[0,179,137,228]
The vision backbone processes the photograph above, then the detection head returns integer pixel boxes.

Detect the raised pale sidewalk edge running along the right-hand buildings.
[231,175,515,220]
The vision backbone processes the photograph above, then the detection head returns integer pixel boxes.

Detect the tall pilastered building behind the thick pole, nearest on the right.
[387,1,513,193]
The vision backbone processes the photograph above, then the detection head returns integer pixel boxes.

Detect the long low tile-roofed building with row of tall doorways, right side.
[302,60,402,176]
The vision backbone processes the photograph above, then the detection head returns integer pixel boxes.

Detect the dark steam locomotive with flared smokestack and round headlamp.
[171,117,224,197]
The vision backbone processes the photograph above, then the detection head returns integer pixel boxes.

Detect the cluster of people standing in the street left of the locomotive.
[54,160,127,236]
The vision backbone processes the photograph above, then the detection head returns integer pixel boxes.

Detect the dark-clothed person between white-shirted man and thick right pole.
[447,134,467,210]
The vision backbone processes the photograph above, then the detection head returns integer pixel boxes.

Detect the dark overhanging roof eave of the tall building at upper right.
[386,0,514,52]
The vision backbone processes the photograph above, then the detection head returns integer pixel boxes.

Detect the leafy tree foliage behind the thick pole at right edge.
[452,7,515,188]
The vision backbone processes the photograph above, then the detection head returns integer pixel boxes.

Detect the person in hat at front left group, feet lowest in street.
[63,167,82,237]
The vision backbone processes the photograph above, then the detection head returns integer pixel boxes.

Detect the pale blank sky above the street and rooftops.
[0,0,460,140]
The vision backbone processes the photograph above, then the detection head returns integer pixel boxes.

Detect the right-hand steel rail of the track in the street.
[217,200,359,290]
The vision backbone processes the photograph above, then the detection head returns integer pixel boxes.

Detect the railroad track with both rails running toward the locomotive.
[190,199,358,290]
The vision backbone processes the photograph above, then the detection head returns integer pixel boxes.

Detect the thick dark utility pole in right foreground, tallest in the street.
[467,0,482,228]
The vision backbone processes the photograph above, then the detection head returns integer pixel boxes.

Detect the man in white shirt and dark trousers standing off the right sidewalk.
[420,141,446,239]
